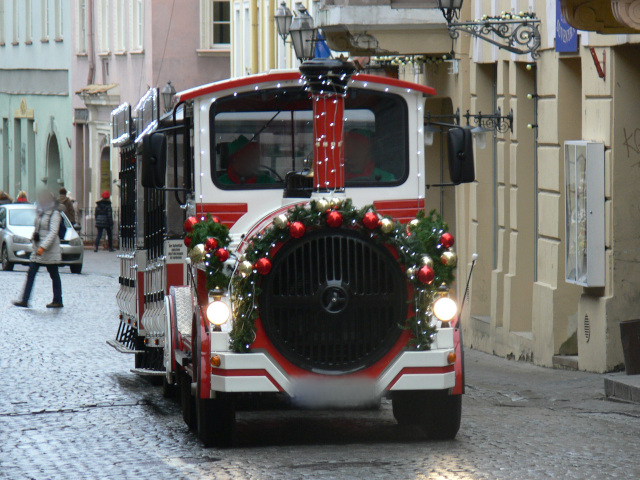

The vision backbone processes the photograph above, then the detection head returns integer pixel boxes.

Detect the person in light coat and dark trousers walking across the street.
[13,190,63,308]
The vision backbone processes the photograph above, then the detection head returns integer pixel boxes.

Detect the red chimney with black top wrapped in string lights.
[300,59,355,193]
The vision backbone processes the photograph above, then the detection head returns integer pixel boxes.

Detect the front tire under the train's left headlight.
[196,392,236,448]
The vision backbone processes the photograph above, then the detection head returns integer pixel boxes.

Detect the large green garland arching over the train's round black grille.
[231,199,455,352]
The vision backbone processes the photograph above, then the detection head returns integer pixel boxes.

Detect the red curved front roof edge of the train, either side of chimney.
[176,70,436,102]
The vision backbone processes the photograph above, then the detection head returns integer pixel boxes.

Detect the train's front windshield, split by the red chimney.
[210,87,409,189]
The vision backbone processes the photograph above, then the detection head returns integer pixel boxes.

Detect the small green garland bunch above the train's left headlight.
[187,214,231,290]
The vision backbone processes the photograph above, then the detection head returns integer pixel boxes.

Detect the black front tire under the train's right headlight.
[392,390,462,440]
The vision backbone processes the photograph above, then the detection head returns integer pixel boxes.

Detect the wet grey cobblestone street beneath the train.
[0,251,640,480]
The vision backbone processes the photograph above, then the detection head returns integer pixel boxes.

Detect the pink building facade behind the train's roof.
[71,0,230,212]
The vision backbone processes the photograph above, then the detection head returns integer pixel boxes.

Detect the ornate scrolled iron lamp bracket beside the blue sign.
[448,13,541,59]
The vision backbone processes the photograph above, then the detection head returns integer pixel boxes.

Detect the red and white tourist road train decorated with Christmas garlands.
[109,60,473,446]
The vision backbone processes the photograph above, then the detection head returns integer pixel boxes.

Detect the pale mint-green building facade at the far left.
[0,0,73,200]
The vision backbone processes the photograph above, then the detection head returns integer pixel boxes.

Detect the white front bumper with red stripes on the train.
[210,328,456,405]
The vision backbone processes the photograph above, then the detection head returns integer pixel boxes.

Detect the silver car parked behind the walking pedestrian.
[0,203,84,273]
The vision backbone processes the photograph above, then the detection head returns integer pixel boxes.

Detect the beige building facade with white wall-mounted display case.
[318,0,640,372]
